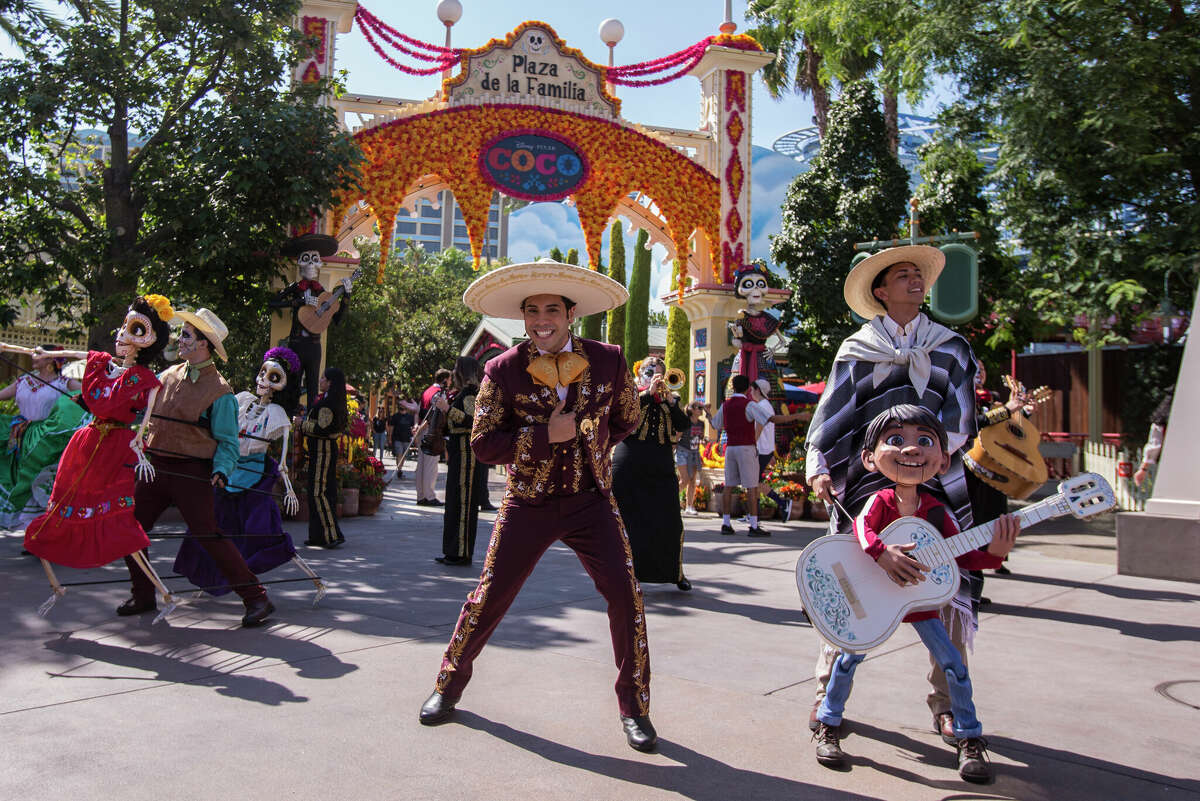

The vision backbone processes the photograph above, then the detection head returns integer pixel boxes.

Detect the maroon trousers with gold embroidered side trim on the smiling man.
[437,489,650,717]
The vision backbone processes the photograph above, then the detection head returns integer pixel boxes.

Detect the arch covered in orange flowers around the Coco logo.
[335,106,721,281]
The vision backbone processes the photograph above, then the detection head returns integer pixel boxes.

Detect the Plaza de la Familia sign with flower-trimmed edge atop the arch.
[444,22,620,120]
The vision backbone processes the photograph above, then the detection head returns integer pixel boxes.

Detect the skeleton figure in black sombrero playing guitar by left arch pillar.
[269,234,362,405]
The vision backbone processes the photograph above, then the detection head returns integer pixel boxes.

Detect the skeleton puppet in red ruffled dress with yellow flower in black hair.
[25,295,174,614]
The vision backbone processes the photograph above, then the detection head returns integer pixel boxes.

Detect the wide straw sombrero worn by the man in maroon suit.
[462,259,629,320]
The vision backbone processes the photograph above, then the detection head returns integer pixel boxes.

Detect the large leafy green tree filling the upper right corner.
[917,0,1200,345]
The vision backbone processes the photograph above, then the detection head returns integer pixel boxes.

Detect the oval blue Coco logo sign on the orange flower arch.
[479,132,588,200]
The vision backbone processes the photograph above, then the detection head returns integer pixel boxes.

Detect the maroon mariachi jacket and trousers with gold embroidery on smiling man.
[437,336,650,717]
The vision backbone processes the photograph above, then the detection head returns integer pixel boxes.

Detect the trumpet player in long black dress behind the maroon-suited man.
[612,356,691,591]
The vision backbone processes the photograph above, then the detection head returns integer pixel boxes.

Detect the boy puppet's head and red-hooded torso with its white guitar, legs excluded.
[796,406,1116,654]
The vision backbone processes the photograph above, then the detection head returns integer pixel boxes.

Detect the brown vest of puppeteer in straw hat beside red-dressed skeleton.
[146,361,233,459]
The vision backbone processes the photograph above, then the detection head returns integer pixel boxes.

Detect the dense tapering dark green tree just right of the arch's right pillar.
[770,82,908,378]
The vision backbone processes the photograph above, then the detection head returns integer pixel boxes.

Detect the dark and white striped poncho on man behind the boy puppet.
[806,314,976,531]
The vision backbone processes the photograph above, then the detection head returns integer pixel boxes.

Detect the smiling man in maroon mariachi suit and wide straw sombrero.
[420,260,658,751]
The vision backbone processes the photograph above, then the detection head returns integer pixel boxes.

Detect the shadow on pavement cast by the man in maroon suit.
[455,710,871,801]
